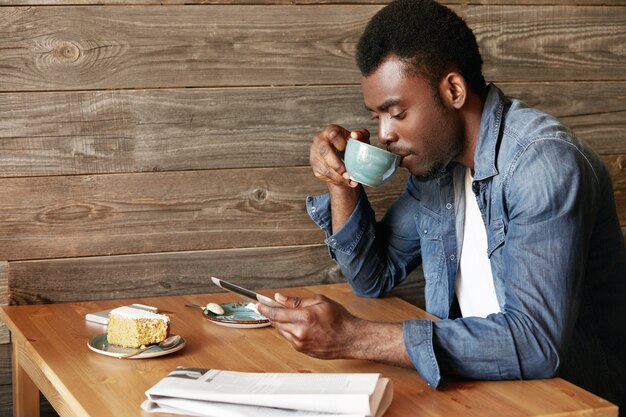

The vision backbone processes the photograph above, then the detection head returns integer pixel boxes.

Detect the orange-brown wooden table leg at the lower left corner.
[13,340,40,417]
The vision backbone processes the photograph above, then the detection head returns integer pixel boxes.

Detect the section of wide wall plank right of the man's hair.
[455,6,626,81]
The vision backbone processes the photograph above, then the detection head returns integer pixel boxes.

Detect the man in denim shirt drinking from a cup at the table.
[255,0,626,406]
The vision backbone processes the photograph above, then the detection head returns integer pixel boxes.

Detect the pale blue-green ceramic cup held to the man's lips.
[343,139,400,187]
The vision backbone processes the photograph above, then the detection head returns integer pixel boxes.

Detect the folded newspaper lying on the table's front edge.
[141,366,393,417]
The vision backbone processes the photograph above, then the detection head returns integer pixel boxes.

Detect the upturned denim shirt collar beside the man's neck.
[474,84,506,181]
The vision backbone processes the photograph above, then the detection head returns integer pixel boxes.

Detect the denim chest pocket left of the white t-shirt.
[415,209,445,282]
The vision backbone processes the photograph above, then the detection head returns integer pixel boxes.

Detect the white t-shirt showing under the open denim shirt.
[456,168,500,317]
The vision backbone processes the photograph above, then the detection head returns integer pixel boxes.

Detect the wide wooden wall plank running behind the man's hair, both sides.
[0,4,626,91]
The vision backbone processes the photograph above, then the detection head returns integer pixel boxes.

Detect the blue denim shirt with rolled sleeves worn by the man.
[307,85,626,405]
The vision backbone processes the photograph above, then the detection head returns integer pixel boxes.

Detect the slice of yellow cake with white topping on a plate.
[107,306,170,348]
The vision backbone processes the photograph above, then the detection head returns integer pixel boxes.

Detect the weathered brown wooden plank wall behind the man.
[0,0,626,416]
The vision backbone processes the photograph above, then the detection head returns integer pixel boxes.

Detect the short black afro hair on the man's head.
[356,0,486,94]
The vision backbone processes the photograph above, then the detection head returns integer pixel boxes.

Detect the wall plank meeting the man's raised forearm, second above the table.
[0,167,406,260]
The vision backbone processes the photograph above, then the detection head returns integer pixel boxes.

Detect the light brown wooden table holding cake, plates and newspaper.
[0,284,617,417]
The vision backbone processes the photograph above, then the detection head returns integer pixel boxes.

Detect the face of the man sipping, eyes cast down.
[361,57,463,178]
